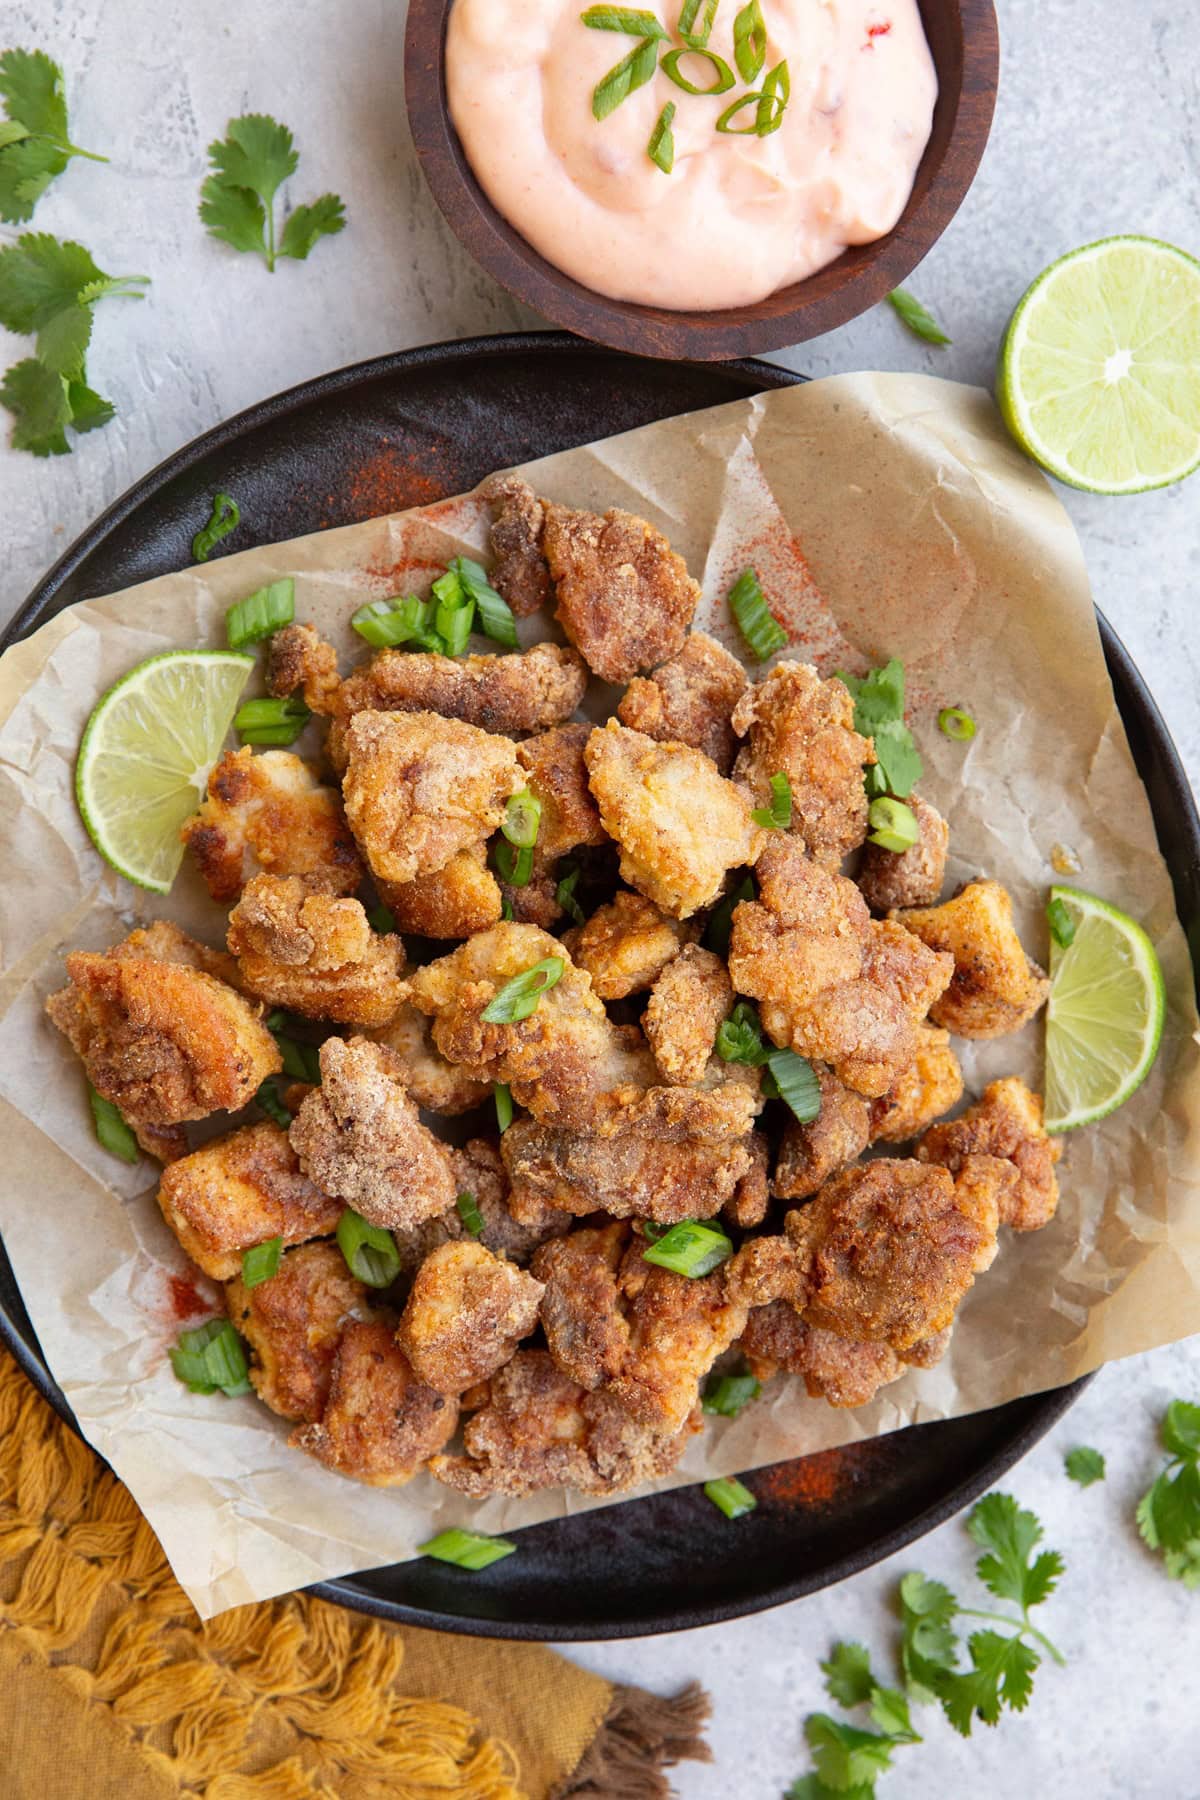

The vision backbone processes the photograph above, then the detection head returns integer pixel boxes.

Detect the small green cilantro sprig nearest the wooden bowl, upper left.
[200,113,345,270]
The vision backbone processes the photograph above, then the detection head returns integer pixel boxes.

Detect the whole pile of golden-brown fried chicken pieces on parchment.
[49,477,1058,1496]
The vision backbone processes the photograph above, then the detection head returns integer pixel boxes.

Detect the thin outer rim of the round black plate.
[0,331,1200,1642]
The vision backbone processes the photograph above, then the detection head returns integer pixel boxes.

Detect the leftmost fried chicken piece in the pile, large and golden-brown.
[45,931,282,1156]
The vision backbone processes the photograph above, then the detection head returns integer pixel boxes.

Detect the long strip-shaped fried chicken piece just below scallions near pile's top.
[329,644,588,772]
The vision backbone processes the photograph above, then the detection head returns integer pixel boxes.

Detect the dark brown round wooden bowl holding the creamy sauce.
[405,0,1000,362]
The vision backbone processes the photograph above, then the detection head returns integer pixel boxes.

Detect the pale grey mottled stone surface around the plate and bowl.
[0,0,1200,1800]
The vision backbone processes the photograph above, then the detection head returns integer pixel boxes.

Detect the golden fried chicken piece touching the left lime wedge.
[182,749,363,900]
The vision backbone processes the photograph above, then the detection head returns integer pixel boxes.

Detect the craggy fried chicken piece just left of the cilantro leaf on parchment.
[732,662,874,869]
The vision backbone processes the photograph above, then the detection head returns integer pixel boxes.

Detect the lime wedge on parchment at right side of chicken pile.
[1045,887,1166,1130]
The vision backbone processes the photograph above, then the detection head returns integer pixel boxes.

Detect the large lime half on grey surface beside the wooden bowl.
[997,238,1200,493]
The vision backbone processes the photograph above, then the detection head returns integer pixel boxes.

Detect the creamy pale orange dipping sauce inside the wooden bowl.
[446,0,937,311]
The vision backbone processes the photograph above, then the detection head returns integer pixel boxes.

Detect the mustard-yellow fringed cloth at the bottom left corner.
[0,1352,709,1800]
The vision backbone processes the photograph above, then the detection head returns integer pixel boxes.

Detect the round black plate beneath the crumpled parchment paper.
[0,333,1200,1640]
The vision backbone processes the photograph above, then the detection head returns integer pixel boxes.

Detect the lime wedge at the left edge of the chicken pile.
[76,650,254,895]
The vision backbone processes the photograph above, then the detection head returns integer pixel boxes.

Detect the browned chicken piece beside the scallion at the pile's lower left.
[225,1242,371,1424]
